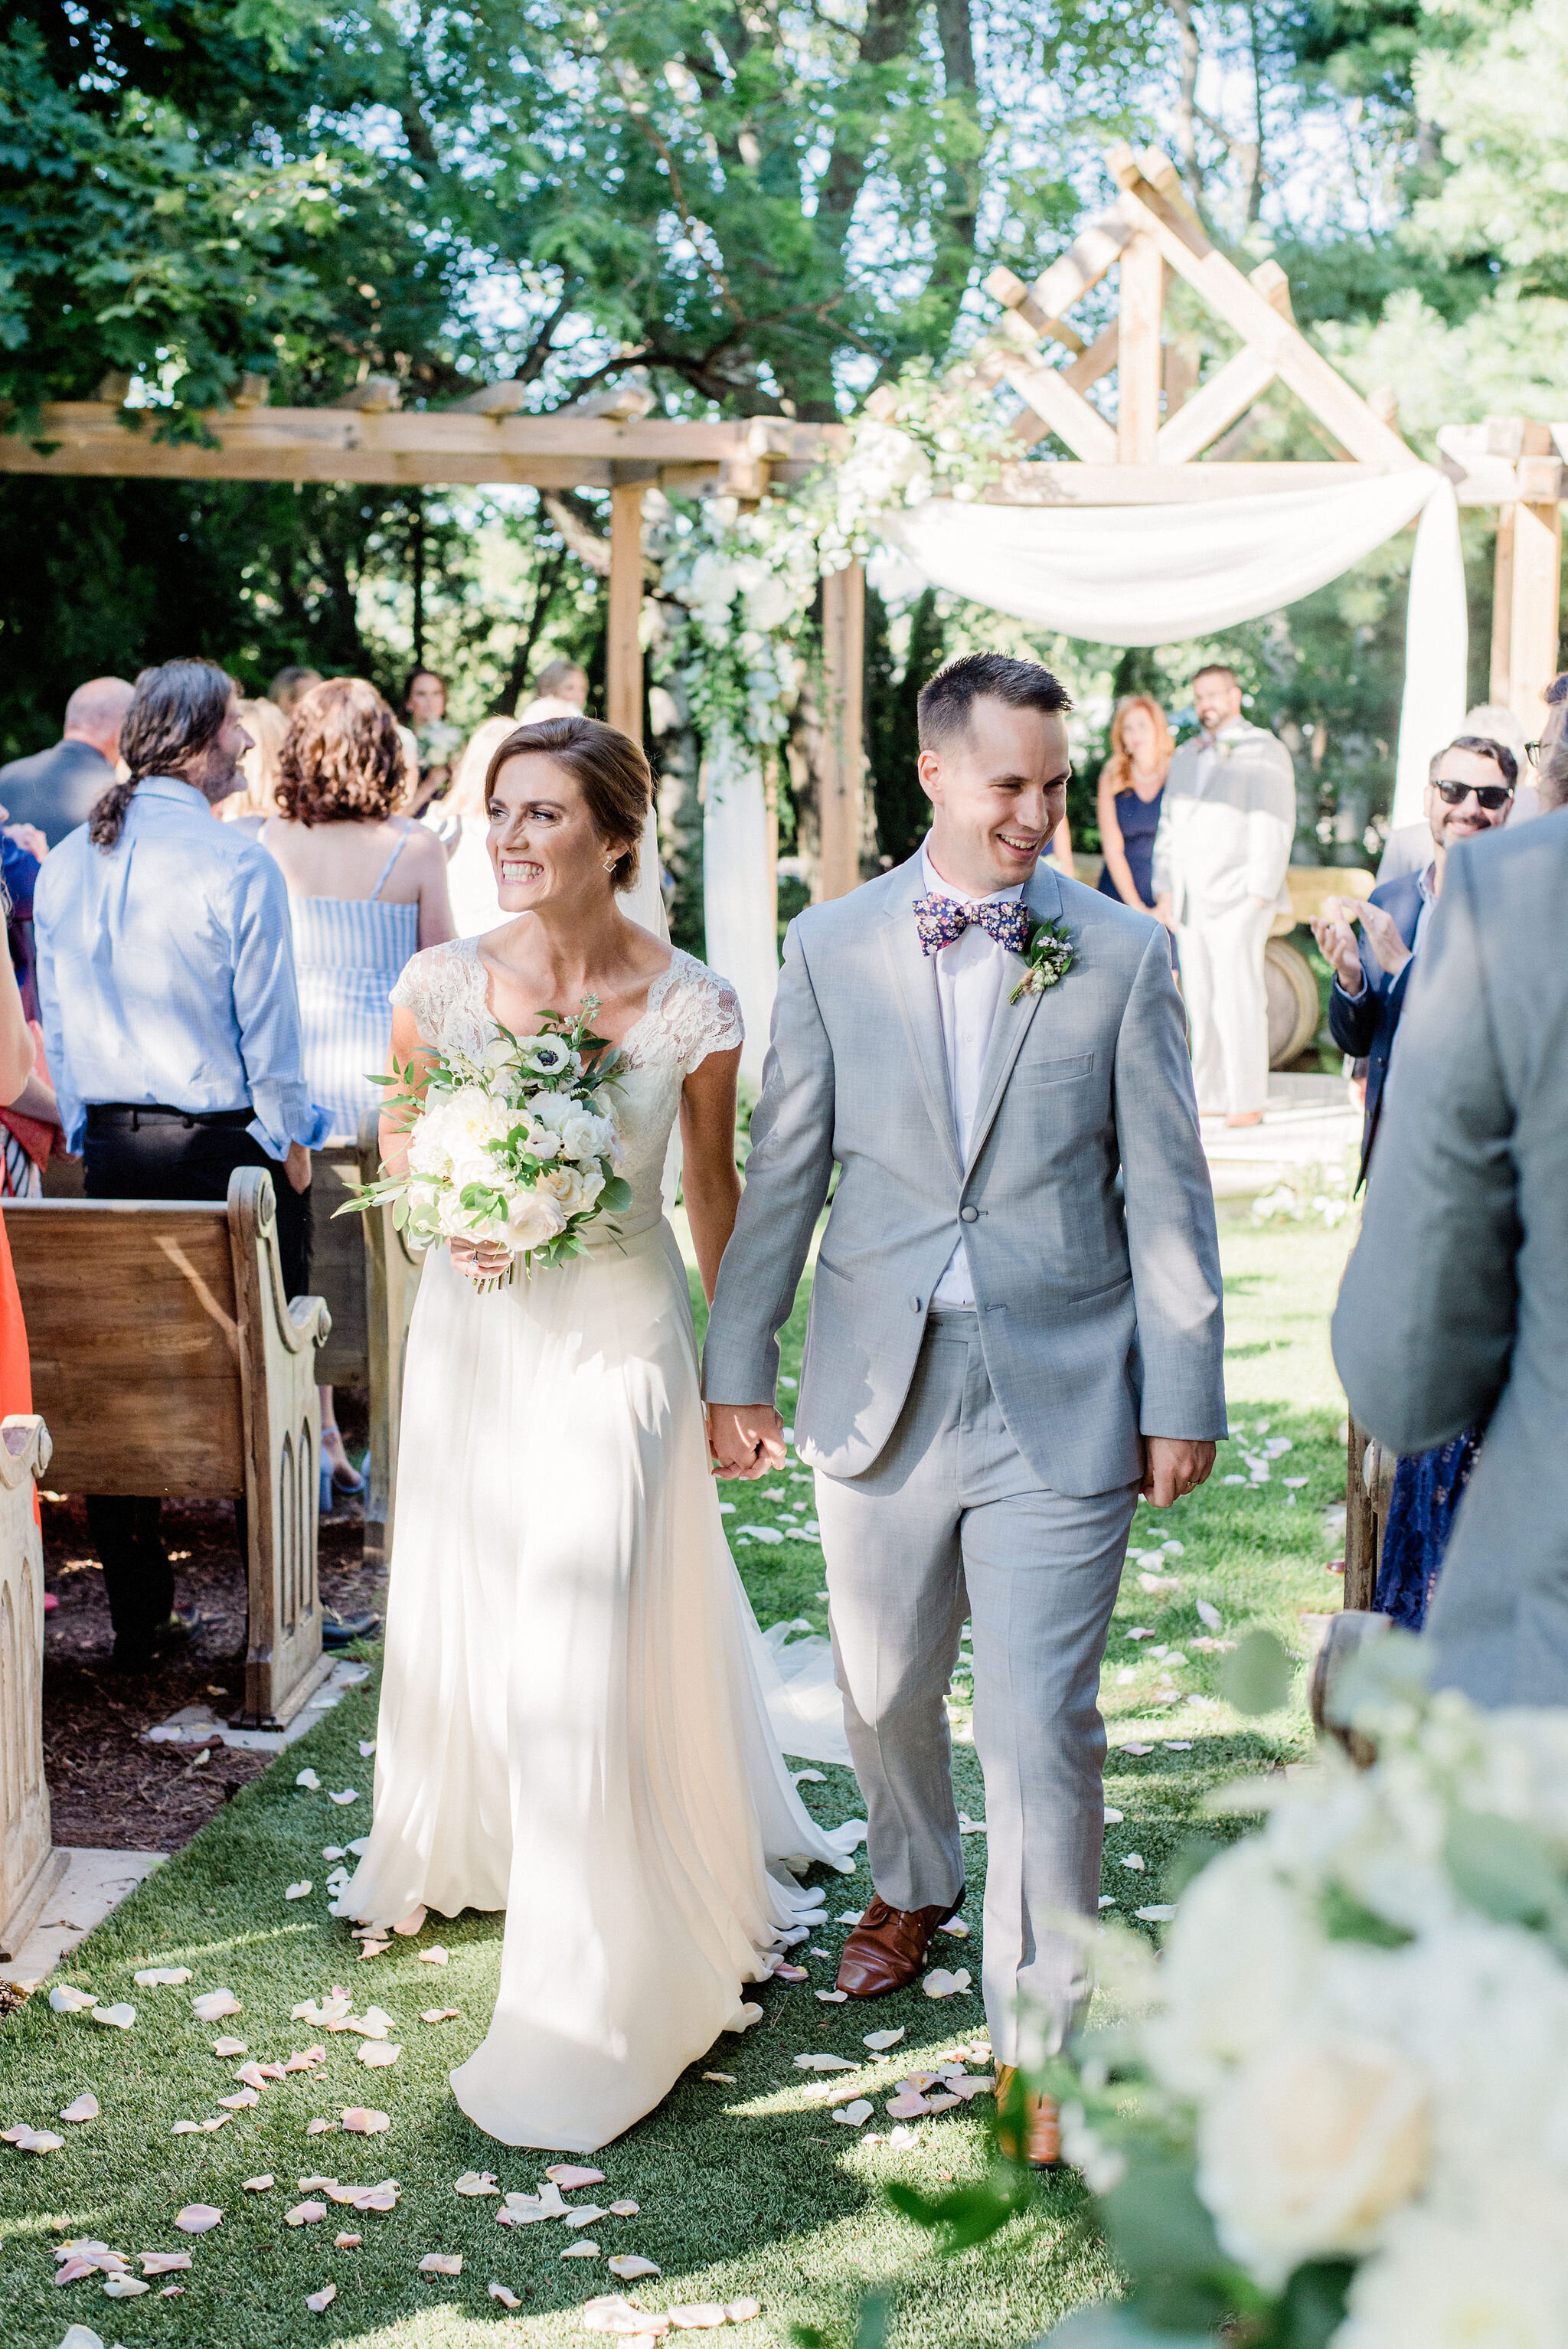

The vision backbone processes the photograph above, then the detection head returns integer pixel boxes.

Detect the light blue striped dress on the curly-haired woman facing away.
[263,827,420,1142]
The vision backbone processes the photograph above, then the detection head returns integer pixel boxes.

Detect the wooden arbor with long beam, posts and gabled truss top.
[0,148,1568,897]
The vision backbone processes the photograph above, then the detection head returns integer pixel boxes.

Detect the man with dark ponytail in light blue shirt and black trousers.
[33,660,324,1670]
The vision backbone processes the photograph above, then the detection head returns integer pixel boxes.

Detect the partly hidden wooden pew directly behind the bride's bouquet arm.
[310,1109,425,1567]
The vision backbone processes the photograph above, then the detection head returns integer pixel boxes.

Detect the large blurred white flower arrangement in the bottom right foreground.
[1054,1639,1568,2349]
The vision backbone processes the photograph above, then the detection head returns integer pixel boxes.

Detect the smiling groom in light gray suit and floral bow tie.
[704,653,1225,2158]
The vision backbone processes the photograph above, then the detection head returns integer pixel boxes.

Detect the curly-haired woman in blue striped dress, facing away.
[260,677,453,1491]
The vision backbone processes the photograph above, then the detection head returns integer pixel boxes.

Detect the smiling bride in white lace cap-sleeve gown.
[335,719,864,2151]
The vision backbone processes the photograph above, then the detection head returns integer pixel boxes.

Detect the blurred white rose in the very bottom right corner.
[1333,2197,1568,2349]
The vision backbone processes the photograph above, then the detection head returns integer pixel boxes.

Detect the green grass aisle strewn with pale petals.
[0,1210,1348,2349]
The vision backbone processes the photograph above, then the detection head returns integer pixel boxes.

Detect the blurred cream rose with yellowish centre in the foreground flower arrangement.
[1197,2030,1432,2292]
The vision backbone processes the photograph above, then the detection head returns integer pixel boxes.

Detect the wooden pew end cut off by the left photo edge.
[0,1414,66,1962]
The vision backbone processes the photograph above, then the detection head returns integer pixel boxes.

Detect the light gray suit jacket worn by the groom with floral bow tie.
[704,855,1225,1494]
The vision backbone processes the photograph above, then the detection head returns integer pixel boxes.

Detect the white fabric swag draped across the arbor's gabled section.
[878,465,1469,822]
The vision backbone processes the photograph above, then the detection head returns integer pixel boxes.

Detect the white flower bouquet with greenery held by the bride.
[338,996,632,1289]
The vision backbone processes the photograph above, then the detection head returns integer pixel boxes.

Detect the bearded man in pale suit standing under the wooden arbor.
[1152,662,1295,1125]
